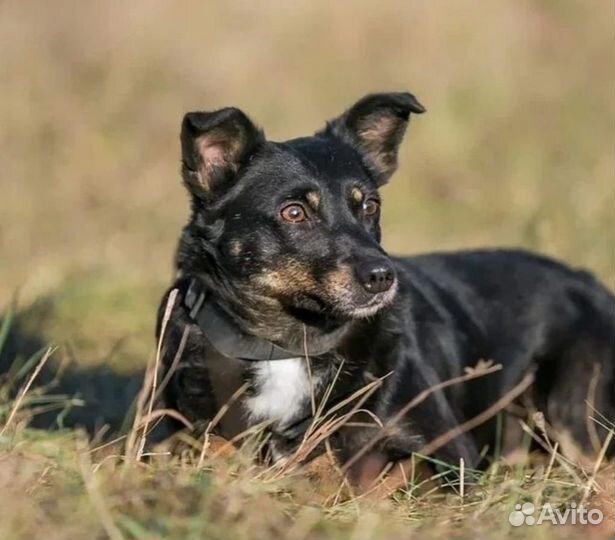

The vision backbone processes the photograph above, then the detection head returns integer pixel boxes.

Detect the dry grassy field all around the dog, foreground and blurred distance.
[0,0,615,540]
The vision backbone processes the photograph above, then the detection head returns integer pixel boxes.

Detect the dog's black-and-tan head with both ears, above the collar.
[178,93,424,333]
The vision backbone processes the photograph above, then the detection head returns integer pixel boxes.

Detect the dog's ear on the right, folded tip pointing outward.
[319,92,426,186]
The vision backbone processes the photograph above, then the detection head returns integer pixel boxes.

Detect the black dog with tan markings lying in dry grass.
[158,93,615,486]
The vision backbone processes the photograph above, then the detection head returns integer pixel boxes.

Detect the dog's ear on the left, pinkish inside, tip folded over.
[181,107,265,200]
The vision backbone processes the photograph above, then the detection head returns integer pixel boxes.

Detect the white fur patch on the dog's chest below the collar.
[244,358,316,425]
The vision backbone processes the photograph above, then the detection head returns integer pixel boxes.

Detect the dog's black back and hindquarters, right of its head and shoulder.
[398,250,615,460]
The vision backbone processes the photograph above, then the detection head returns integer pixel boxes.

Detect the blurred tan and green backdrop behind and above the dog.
[0,0,615,424]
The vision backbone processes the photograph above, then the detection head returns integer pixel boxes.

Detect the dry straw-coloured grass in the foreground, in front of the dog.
[0,317,615,540]
